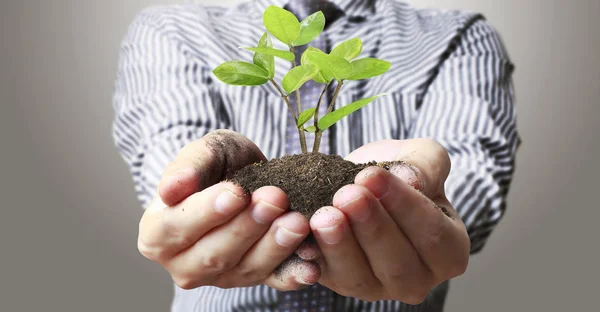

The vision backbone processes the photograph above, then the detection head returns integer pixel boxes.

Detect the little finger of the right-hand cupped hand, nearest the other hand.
[310,207,385,298]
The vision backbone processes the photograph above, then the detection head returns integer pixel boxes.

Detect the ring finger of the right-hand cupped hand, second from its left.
[333,185,435,301]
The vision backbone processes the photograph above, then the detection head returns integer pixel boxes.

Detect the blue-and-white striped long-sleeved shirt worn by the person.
[113,0,520,312]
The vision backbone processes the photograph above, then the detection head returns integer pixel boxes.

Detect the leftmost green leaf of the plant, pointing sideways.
[213,61,269,86]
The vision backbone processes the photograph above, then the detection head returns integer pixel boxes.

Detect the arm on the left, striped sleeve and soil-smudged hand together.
[114,9,319,290]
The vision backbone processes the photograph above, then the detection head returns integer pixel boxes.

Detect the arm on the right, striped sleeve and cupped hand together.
[311,18,518,304]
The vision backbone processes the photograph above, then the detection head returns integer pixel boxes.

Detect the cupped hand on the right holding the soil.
[310,139,470,304]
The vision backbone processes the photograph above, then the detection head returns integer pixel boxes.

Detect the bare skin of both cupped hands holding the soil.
[138,130,470,304]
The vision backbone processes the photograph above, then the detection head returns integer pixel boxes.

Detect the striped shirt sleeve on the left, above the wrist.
[113,7,227,207]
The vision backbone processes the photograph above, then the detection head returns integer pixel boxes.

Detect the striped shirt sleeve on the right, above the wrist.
[411,20,520,253]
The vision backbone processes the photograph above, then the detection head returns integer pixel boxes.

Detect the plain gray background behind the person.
[0,0,600,311]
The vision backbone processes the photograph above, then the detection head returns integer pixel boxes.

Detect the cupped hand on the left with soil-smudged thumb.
[138,130,320,290]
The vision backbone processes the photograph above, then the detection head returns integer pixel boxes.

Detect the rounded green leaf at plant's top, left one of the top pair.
[263,5,300,47]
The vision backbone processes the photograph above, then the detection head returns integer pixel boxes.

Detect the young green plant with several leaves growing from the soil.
[213,6,391,153]
